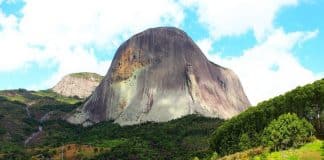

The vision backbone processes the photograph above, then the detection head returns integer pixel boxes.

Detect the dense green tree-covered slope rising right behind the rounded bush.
[211,80,324,155]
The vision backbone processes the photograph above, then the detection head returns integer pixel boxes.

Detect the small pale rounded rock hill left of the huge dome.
[52,72,103,98]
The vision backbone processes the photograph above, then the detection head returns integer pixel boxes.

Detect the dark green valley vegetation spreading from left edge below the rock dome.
[0,89,223,159]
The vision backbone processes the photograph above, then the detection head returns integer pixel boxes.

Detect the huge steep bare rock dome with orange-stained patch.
[67,27,250,126]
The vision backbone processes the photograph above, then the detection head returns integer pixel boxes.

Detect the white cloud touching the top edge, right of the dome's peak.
[181,0,298,40]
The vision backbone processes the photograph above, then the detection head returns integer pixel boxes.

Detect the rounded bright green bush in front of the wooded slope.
[262,113,315,150]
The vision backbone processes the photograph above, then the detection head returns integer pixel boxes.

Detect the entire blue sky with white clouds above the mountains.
[0,0,324,104]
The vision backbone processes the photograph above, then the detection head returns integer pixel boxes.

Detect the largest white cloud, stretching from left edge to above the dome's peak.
[0,0,184,89]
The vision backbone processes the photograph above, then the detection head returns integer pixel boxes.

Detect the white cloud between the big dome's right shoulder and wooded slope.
[203,29,320,104]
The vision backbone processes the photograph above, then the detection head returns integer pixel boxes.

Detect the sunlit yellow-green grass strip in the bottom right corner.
[254,140,324,160]
